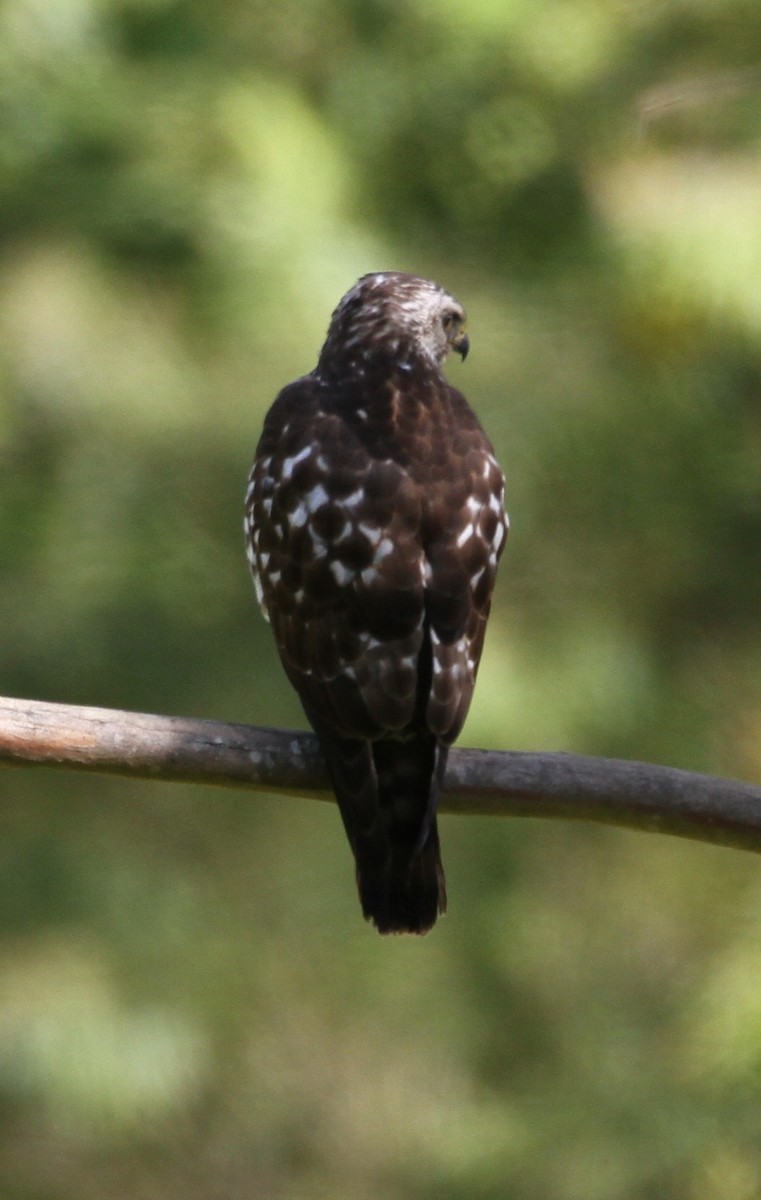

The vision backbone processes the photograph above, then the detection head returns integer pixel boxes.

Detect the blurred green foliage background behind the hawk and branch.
[0,0,761,1200]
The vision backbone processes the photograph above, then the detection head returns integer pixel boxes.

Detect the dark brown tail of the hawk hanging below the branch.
[312,732,448,934]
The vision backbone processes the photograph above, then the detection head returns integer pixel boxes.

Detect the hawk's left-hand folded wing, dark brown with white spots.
[246,377,425,737]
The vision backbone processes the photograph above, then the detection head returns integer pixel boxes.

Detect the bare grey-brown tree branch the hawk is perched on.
[0,697,761,852]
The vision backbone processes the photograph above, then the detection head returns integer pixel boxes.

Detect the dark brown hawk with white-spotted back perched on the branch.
[245,271,508,934]
